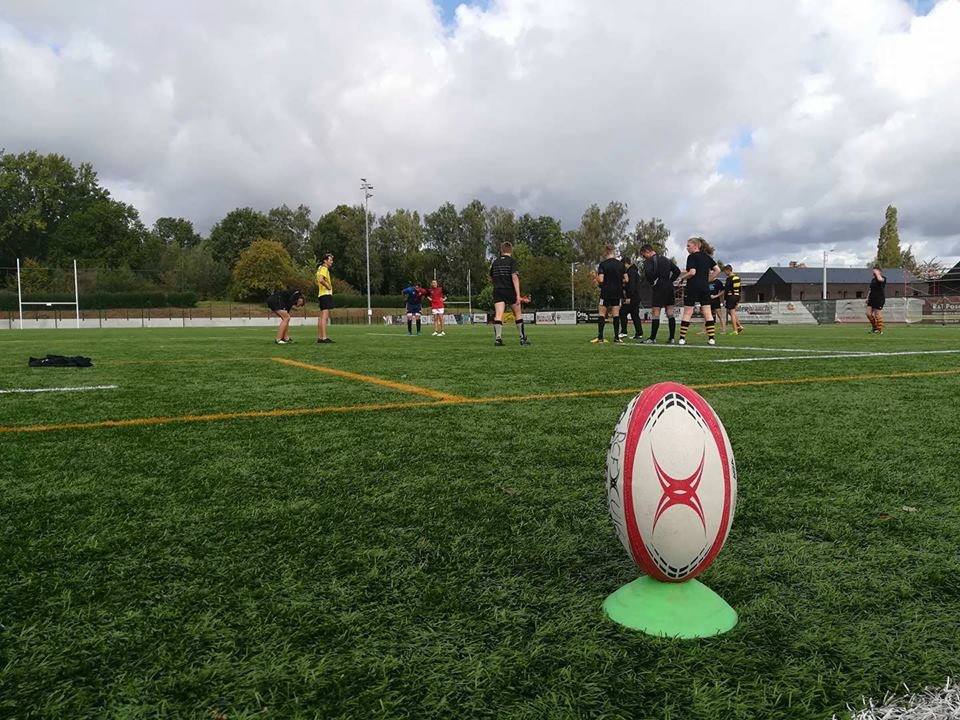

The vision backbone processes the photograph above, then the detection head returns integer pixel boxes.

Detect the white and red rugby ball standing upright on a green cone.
[606,382,737,582]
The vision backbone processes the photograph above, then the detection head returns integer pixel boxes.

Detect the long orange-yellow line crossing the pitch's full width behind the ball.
[0,369,960,433]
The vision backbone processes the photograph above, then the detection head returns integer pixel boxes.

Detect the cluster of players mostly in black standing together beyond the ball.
[590,237,743,345]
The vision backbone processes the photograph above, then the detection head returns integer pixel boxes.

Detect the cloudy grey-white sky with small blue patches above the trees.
[0,0,960,269]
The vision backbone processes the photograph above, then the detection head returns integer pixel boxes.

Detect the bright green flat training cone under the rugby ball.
[603,575,737,640]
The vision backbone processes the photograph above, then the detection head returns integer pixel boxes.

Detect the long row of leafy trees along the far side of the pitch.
[0,151,670,306]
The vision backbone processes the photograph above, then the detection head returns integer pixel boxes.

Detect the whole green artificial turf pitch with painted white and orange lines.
[0,325,960,720]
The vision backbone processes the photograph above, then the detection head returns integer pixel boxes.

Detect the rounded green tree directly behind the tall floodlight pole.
[310,205,383,294]
